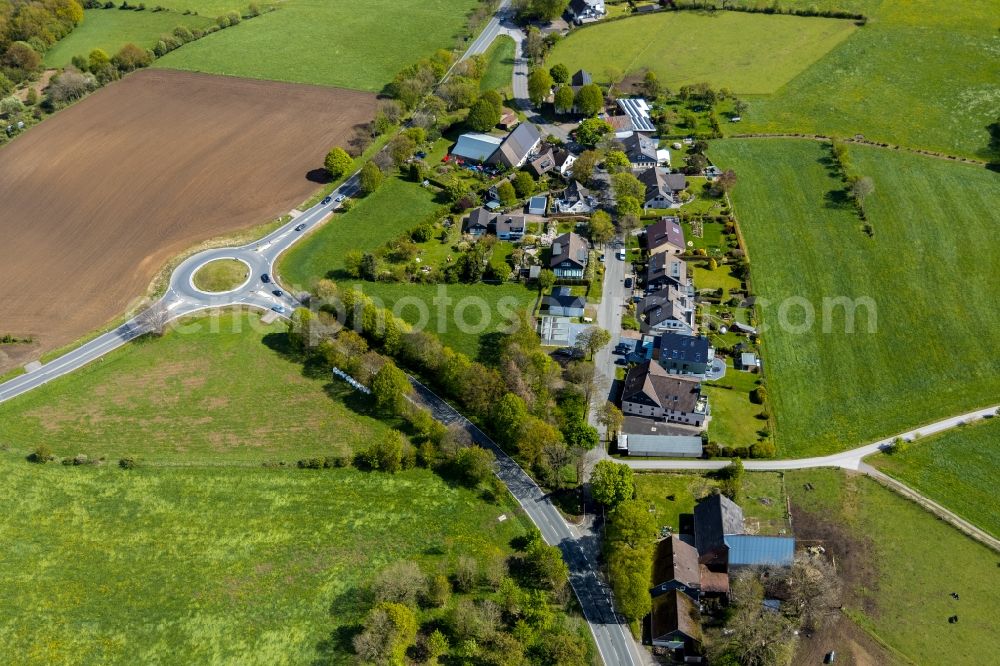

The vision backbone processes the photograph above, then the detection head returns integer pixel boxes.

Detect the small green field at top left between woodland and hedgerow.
[45,8,214,67]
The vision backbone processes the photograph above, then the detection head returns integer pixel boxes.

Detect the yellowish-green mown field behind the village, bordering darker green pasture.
[546,12,857,94]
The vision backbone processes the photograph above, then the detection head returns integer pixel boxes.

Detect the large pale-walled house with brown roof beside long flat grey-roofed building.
[622,361,708,427]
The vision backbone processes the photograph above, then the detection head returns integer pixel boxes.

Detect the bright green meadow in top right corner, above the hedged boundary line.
[736,0,1000,157]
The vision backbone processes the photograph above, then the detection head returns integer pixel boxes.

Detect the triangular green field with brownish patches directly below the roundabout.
[0,312,402,464]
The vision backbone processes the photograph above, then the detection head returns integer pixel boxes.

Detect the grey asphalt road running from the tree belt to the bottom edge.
[410,377,644,666]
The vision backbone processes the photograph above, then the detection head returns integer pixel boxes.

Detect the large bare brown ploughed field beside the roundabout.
[0,71,375,373]
